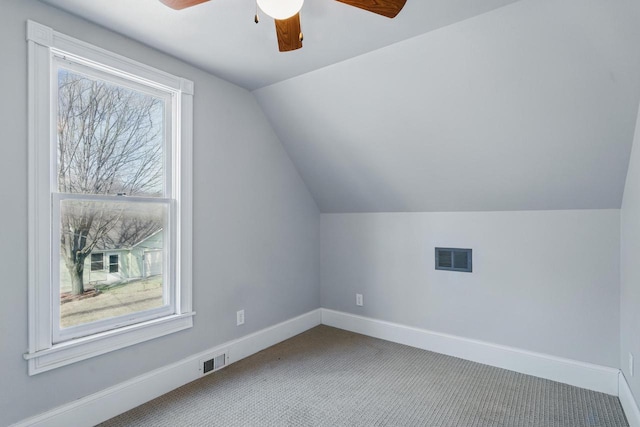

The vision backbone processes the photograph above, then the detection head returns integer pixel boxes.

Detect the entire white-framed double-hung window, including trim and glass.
[25,21,194,375]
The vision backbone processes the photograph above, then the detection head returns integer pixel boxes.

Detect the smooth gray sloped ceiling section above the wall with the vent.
[254,0,640,212]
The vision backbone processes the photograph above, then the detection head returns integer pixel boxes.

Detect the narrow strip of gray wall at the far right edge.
[620,106,640,405]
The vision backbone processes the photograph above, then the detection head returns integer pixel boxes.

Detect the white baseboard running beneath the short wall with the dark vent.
[322,308,620,396]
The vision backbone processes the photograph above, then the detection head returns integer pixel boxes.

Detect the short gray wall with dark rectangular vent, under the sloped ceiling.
[320,210,624,367]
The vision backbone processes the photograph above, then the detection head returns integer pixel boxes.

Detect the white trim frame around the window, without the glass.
[24,21,195,375]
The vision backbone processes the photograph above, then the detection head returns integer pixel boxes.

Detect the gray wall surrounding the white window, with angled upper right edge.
[0,0,320,425]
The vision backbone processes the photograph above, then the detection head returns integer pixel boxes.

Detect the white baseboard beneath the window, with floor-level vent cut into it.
[13,309,322,427]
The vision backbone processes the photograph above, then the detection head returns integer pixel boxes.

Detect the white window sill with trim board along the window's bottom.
[24,312,195,375]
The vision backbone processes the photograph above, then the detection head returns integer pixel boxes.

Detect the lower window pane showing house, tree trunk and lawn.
[59,200,169,328]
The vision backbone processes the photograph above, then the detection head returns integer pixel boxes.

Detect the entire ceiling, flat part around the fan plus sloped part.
[44,0,640,212]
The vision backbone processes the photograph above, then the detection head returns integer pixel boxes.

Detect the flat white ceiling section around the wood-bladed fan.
[42,0,516,90]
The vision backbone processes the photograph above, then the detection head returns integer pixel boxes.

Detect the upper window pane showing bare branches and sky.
[57,68,165,196]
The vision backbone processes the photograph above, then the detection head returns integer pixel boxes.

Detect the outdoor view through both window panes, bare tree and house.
[54,63,170,340]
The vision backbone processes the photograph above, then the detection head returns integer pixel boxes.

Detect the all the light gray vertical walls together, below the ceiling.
[0,0,640,425]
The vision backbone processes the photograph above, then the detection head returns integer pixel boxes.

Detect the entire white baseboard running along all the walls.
[13,309,624,427]
